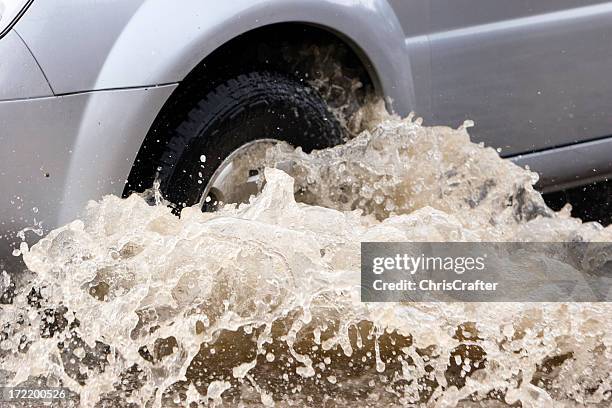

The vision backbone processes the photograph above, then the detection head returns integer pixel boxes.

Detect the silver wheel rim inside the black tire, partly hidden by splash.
[200,139,278,211]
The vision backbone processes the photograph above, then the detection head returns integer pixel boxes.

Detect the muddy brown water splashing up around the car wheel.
[0,110,612,407]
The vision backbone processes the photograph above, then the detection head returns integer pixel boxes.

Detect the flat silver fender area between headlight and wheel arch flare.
[14,0,145,95]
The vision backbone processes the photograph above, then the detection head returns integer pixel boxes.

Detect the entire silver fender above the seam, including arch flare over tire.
[15,0,414,114]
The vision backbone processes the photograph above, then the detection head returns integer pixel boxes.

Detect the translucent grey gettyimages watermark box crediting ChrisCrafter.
[361,242,612,302]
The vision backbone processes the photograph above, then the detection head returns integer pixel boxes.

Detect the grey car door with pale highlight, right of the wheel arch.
[428,0,612,156]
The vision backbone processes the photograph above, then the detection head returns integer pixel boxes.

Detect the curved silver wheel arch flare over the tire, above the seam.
[95,0,414,108]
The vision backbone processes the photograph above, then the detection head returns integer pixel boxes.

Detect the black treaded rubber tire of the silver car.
[157,72,343,211]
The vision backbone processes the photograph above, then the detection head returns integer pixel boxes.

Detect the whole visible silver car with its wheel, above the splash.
[0,0,612,258]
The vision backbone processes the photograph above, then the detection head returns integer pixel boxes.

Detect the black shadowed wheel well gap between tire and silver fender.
[123,12,412,196]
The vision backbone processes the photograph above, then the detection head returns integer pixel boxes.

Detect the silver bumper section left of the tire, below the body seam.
[0,82,175,266]
